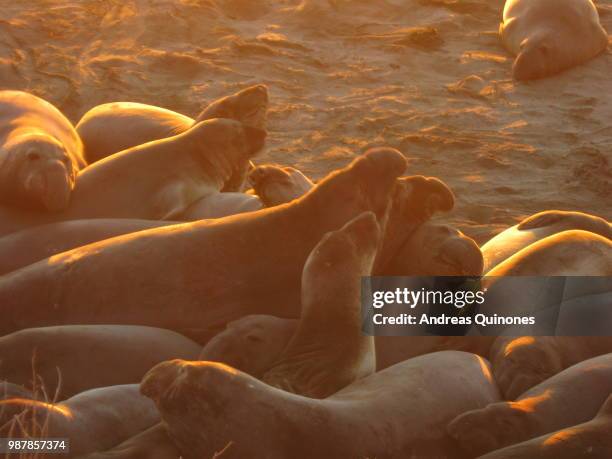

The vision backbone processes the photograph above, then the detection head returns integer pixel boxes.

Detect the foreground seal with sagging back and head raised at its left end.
[140,352,499,459]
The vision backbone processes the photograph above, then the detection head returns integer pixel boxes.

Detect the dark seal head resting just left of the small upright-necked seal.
[198,314,299,379]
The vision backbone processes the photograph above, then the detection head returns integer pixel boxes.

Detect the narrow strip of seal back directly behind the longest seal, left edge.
[0,219,173,275]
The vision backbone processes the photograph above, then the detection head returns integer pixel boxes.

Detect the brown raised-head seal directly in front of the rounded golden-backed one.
[0,119,266,239]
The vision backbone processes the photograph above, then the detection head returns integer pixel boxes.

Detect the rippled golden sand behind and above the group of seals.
[0,0,612,241]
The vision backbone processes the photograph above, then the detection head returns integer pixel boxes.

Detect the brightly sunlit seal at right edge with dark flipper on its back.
[481,210,612,273]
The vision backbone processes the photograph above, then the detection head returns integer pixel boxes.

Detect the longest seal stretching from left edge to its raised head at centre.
[0,149,420,342]
